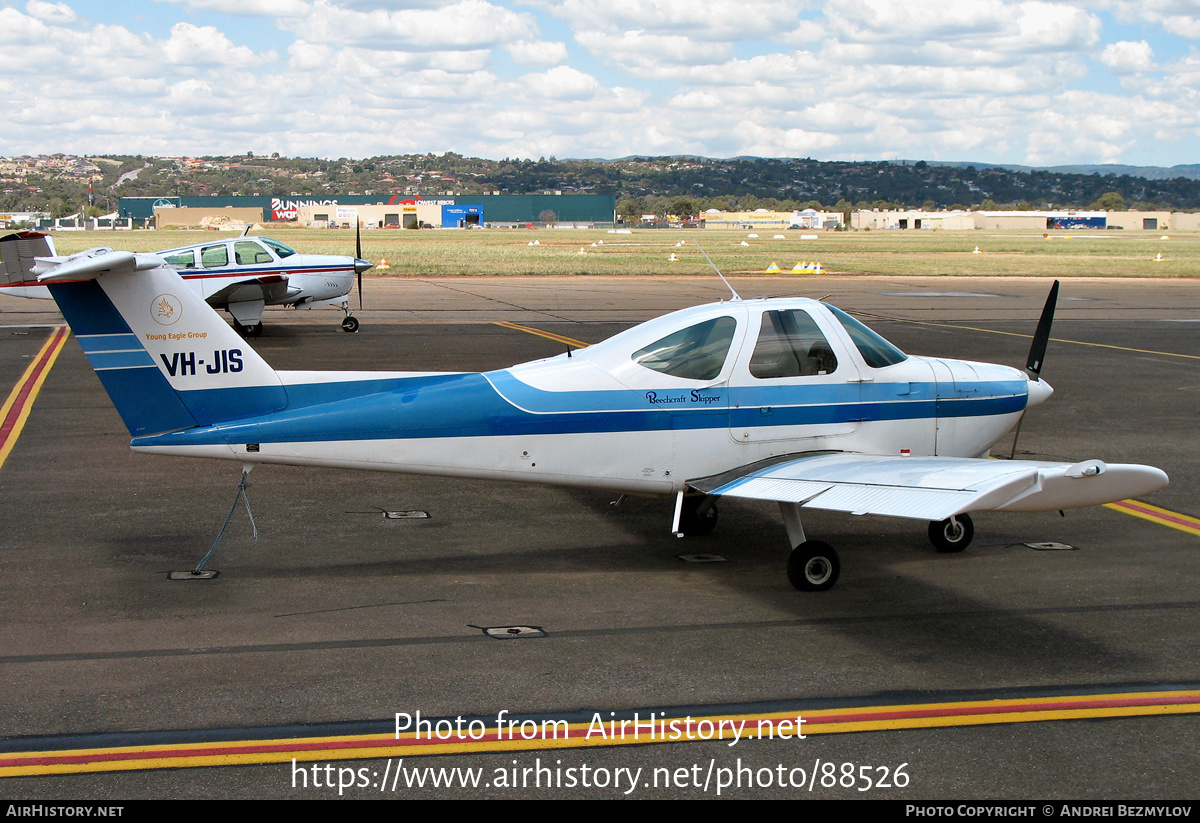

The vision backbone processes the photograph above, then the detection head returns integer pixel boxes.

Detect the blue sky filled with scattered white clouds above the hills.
[0,0,1200,166]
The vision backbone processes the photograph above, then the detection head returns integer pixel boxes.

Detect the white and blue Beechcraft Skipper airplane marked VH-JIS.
[40,252,1168,590]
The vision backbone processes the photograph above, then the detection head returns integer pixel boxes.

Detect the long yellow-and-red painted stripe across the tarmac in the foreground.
[0,689,1200,777]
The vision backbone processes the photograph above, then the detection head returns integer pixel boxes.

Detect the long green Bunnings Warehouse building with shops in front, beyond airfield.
[118,194,617,228]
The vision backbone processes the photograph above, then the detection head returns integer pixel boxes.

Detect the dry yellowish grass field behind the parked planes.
[46,226,1200,277]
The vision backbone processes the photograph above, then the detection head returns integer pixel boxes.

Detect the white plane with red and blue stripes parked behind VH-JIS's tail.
[0,227,371,337]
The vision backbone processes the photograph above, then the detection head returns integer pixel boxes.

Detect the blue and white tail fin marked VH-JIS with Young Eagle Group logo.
[38,252,288,437]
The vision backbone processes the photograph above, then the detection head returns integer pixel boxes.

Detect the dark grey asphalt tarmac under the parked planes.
[0,277,1200,800]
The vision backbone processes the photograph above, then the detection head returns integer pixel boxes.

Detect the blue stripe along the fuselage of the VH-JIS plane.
[133,372,1027,446]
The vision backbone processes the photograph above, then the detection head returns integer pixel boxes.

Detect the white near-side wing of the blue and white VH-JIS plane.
[689,452,1168,521]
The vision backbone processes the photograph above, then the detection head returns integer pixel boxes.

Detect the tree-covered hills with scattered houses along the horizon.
[0,152,1200,220]
